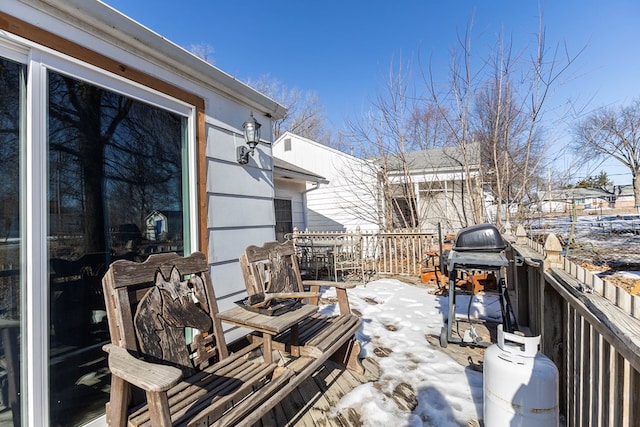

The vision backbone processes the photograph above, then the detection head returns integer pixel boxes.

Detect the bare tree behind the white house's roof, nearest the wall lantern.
[247,75,331,145]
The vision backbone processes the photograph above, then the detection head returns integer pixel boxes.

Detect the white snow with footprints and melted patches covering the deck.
[322,279,501,427]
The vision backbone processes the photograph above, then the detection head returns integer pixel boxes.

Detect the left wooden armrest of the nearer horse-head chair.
[102,344,182,392]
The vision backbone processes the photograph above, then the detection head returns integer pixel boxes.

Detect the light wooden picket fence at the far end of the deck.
[289,231,439,276]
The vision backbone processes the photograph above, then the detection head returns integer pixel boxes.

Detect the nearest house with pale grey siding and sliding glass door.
[0,0,286,426]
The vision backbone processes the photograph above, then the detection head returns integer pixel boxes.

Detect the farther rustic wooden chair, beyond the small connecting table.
[240,241,364,373]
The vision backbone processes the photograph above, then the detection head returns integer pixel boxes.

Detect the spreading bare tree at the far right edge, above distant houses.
[572,98,640,208]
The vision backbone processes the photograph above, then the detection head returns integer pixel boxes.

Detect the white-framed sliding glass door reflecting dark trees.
[0,45,195,427]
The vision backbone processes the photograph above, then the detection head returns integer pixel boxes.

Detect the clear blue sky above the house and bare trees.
[104,0,640,183]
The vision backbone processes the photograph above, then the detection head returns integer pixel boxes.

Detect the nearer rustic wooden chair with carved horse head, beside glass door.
[103,253,295,427]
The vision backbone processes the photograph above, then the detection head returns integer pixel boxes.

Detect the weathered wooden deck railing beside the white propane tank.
[508,229,640,427]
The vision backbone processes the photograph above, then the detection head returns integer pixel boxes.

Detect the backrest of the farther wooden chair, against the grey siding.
[240,240,304,295]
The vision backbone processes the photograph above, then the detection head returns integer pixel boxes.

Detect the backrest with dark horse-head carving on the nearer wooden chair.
[102,252,228,374]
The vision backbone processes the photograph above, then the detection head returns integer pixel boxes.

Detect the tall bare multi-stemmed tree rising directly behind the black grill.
[426,12,576,224]
